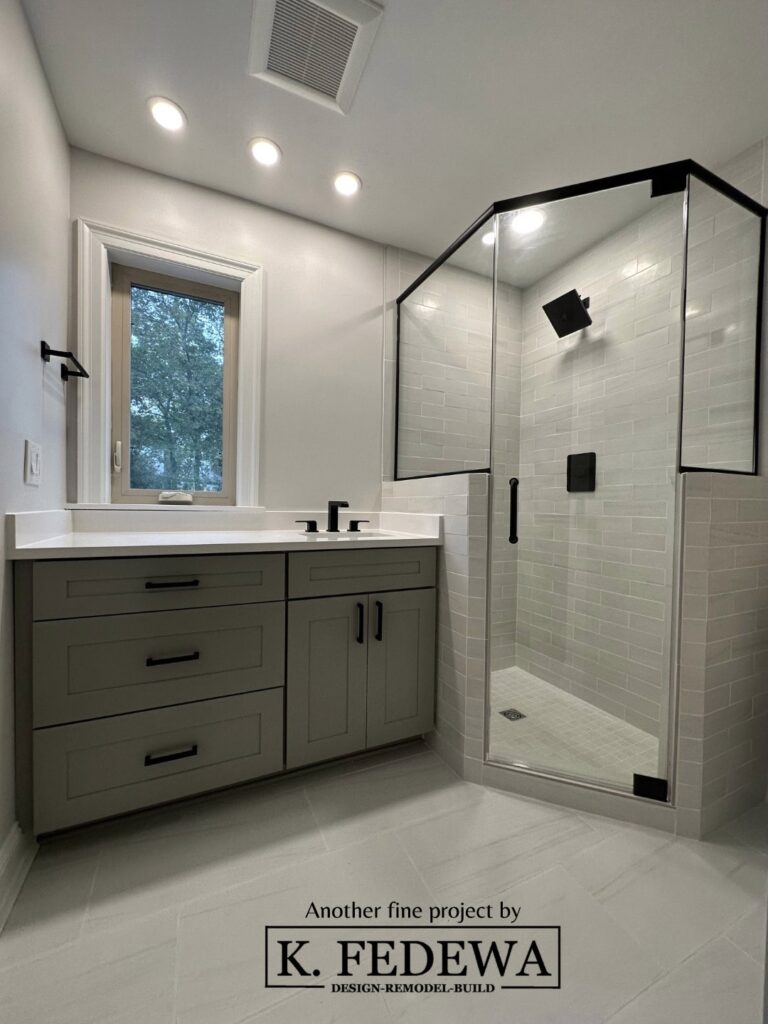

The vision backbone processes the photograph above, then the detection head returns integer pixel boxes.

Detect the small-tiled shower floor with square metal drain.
[489,668,658,788]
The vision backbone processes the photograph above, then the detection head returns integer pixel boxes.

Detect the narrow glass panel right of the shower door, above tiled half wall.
[681,177,760,473]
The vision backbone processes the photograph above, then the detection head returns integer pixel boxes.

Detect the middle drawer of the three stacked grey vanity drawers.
[32,601,285,727]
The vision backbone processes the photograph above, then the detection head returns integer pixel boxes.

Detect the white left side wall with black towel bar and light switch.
[0,0,70,846]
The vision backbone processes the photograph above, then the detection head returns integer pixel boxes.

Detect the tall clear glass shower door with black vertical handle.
[485,181,684,799]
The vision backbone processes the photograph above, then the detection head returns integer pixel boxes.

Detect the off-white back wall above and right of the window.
[72,150,384,509]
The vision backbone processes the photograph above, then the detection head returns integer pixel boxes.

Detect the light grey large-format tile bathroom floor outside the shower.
[0,744,768,1024]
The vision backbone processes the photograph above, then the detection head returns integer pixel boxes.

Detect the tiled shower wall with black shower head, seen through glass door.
[507,197,683,736]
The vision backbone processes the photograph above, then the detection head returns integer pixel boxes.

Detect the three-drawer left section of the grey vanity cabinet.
[14,552,286,835]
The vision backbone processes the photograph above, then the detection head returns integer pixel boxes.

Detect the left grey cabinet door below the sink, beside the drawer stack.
[286,595,368,768]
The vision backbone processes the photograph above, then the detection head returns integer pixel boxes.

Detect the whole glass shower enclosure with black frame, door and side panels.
[395,161,765,800]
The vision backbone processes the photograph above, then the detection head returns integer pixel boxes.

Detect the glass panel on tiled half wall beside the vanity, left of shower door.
[396,220,494,479]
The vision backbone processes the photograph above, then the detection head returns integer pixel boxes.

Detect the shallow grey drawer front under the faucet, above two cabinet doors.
[288,548,436,597]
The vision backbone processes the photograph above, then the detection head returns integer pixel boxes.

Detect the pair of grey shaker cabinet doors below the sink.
[286,589,435,768]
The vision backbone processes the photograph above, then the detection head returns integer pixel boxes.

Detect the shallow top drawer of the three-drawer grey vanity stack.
[33,554,285,620]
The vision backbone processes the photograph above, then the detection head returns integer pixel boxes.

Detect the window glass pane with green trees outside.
[130,285,224,492]
